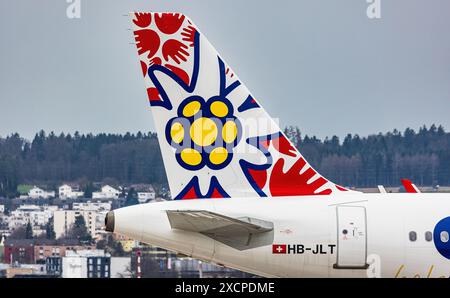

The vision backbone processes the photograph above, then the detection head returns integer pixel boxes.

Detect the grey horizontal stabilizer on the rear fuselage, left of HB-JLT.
[166,210,273,250]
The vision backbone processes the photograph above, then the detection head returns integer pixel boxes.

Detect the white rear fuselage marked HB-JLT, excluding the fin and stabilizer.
[114,193,450,277]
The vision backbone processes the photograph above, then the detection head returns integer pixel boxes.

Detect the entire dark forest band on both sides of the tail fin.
[0,125,450,196]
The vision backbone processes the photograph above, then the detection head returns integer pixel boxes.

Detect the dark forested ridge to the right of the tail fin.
[285,125,450,187]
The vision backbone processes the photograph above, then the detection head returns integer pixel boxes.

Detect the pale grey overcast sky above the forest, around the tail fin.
[0,0,450,138]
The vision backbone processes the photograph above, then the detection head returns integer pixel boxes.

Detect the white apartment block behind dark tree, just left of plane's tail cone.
[53,210,97,238]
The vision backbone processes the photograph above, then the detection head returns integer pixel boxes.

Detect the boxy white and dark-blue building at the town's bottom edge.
[62,250,111,278]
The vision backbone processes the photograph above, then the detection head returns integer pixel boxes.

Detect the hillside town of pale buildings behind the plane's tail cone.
[0,183,248,278]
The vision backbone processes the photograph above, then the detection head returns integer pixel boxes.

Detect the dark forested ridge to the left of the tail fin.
[0,130,166,196]
